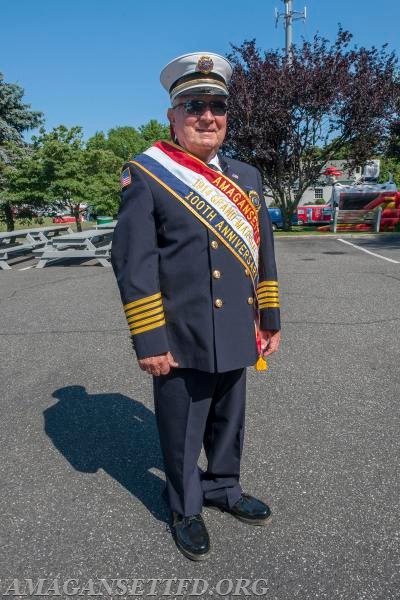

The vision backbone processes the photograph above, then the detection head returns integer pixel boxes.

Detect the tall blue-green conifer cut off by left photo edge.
[0,73,43,231]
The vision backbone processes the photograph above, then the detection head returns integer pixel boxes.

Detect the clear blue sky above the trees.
[0,0,400,137]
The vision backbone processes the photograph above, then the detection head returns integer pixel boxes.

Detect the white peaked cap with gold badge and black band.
[160,52,232,102]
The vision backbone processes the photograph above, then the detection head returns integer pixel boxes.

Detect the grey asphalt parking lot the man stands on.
[0,235,400,600]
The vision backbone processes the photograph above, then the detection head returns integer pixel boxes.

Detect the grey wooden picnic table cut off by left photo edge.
[0,225,72,269]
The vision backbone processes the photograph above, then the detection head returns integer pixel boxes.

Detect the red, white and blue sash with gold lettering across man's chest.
[130,141,260,288]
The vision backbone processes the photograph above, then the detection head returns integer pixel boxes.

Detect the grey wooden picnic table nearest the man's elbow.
[34,228,114,269]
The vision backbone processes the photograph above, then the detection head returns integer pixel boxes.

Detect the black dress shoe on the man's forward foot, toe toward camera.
[171,512,210,560]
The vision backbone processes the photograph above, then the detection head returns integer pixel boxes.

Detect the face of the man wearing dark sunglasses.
[168,95,227,162]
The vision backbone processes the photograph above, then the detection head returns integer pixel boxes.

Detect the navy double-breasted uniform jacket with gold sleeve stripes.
[111,156,280,372]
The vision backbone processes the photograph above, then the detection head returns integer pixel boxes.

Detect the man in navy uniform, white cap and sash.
[112,52,280,560]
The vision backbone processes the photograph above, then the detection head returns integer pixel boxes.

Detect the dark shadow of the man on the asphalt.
[43,385,168,522]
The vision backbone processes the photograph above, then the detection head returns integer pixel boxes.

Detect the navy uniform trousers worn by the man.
[153,369,246,516]
